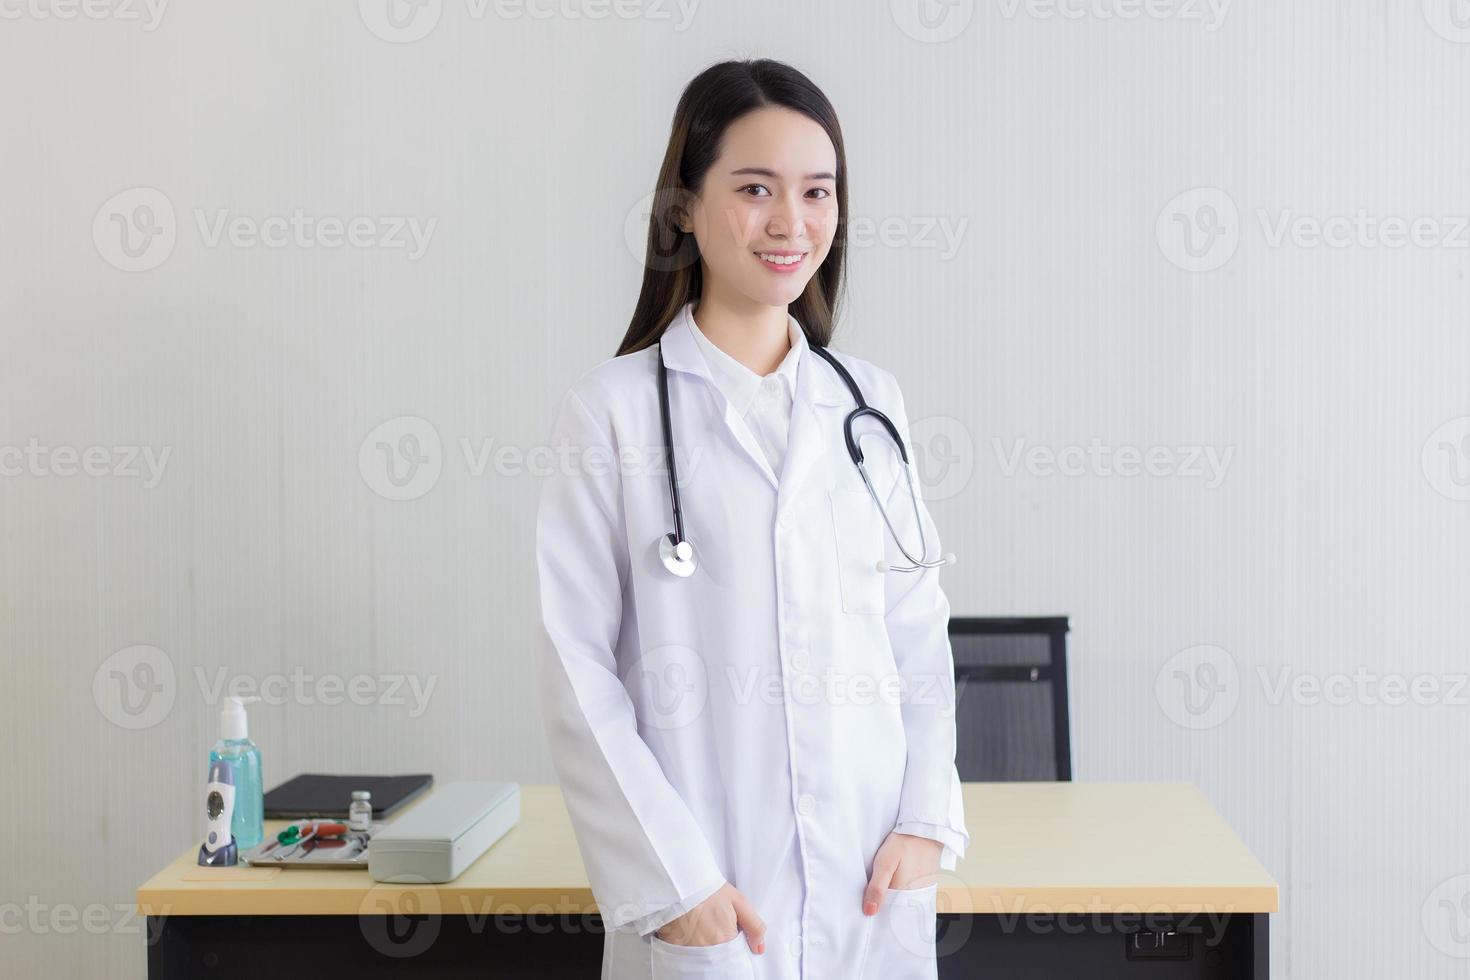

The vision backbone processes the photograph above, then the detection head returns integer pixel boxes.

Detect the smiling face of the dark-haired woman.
[679,107,838,307]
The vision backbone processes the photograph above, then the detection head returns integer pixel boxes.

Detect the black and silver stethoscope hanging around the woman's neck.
[659,344,954,579]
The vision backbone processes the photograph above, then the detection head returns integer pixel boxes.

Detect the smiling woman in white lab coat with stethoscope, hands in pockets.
[537,60,969,980]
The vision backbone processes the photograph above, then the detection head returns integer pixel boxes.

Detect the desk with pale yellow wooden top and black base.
[137,783,1277,980]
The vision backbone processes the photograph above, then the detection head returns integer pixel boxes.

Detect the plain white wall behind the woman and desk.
[0,0,1470,979]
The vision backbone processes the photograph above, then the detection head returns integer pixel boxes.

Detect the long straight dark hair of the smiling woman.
[617,59,847,354]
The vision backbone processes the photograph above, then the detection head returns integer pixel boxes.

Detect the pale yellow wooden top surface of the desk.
[137,783,1277,915]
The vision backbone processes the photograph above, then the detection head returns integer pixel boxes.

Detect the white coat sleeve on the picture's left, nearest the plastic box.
[537,389,725,934]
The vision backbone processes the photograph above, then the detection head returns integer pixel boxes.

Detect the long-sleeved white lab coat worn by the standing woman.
[537,306,969,980]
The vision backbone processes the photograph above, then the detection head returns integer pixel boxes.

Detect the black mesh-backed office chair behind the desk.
[950,616,1072,782]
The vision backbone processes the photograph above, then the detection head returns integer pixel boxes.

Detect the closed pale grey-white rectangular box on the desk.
[368,782,520,883]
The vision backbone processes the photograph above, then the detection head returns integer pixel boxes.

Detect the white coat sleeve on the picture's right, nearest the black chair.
[883,382,970,871]
